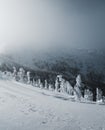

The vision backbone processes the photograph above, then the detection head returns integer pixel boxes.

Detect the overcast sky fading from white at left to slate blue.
[0,0,105,53]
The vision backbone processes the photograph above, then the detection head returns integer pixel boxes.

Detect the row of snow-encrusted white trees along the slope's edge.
[0,67,103,102]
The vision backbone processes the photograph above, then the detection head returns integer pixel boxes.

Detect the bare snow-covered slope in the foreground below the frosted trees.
[0,80,105,130]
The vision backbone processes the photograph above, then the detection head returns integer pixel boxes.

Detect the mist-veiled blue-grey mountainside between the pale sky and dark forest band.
[1,48,105,79]
